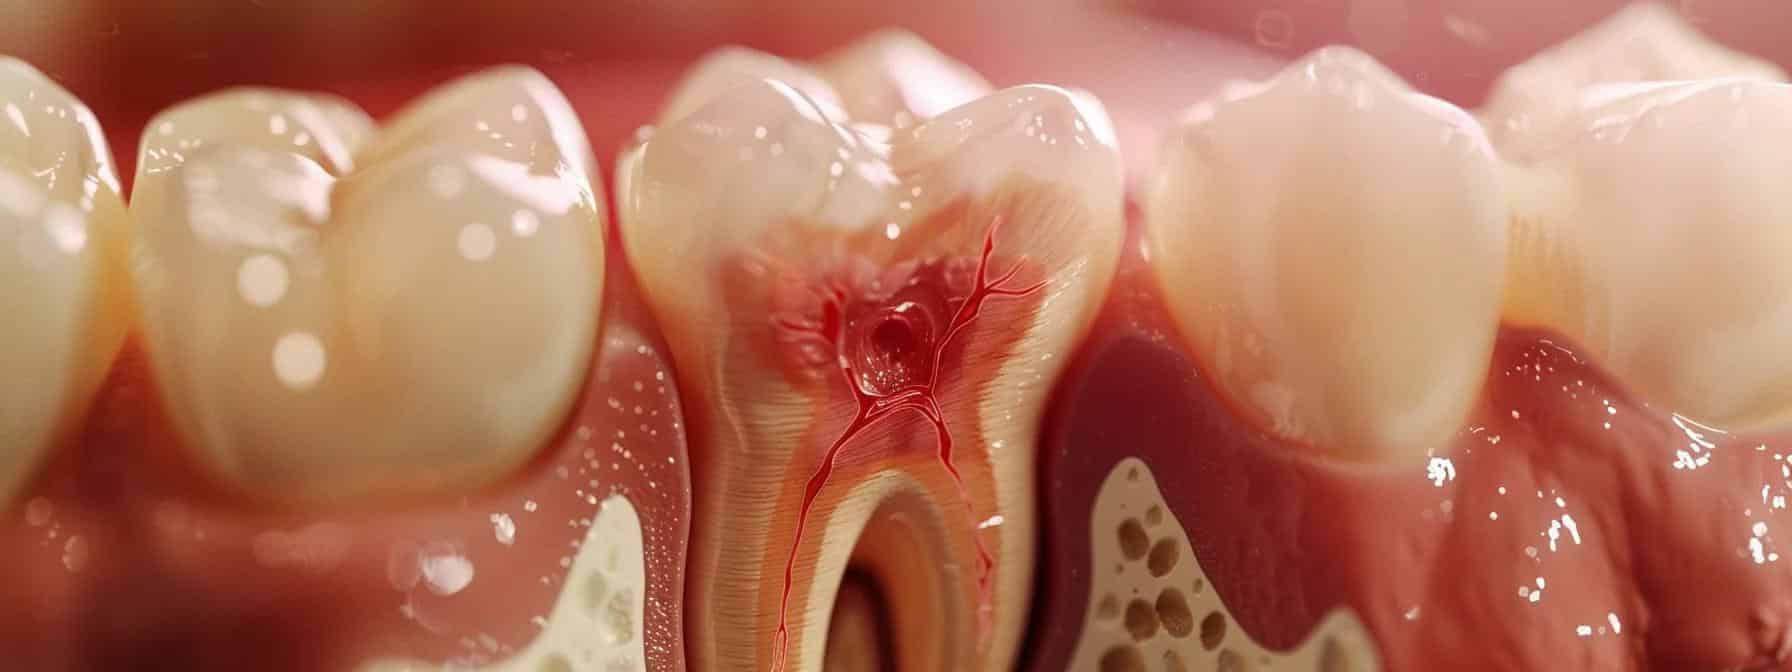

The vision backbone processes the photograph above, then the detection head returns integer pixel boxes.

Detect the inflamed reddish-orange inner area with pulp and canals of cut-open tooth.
[722,191,1047,668]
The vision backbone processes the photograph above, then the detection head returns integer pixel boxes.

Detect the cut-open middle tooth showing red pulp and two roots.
[616,60,1122,670]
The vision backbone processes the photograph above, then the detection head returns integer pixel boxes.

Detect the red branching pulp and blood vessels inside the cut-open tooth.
[772,217,1045,672]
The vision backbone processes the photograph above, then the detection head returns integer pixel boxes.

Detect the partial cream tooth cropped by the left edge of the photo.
[0,59,131,509]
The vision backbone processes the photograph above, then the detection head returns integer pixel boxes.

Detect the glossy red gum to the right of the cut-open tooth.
[1029,221,1792,672]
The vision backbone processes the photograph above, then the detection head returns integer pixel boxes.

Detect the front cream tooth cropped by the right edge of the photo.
[1509,81,1792,428]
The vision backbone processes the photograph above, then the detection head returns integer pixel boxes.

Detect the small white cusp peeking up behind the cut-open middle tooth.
[817,29,989,129]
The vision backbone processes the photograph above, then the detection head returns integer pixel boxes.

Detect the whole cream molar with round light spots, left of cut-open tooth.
[131,68,604,504]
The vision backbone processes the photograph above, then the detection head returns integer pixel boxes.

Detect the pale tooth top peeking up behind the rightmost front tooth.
[1482,2,1785,161]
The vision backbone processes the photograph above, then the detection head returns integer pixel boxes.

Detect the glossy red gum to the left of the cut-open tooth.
[0,232,690,672]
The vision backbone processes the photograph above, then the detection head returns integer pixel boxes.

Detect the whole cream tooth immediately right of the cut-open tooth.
[1145,48,1507,464]
